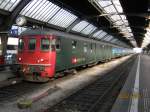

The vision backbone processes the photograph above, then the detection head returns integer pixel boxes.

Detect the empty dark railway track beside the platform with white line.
[44,58,135,112]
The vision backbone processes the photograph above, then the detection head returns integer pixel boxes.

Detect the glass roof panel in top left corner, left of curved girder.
[0,0,21,11]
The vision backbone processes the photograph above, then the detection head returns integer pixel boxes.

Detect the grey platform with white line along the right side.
[111,55,150,112]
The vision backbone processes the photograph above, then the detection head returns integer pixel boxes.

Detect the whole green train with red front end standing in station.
[17,29,131,82]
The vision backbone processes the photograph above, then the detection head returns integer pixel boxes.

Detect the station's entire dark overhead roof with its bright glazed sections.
[0,0,148,47]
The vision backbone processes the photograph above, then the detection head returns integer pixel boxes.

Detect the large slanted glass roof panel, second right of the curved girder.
[48,9,77,28]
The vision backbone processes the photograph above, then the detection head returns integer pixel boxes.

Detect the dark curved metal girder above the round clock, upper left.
[3,0,31,30]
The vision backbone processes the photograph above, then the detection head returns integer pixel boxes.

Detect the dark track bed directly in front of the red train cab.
[0,82,42,105]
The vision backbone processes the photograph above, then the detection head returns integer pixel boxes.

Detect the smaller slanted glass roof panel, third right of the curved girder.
[72,21,89,32]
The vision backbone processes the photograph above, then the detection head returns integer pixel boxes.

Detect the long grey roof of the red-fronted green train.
[20,29,124,47]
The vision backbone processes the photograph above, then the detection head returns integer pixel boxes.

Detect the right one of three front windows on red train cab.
[41,38,50,51]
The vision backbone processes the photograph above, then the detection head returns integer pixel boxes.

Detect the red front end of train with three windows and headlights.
[17,35,56,82]
